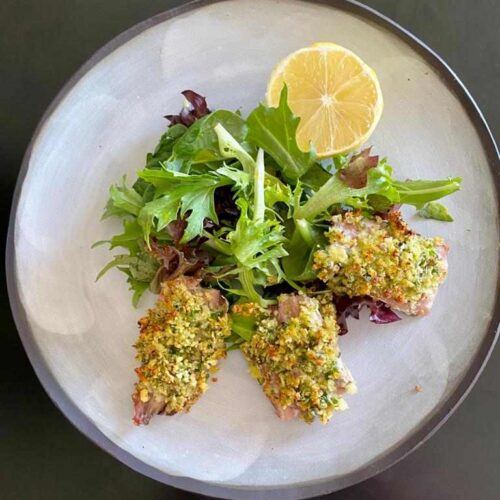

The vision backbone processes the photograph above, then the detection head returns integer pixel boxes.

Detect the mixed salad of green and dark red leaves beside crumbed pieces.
[96,86,461,346]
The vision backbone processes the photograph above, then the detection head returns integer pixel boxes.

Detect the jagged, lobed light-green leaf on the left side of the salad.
[138,168,233,243]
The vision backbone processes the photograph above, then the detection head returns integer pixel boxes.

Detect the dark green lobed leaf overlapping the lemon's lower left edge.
[247,85,315,183]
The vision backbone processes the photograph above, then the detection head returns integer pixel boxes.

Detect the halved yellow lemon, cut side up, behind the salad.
[266,43,384,158]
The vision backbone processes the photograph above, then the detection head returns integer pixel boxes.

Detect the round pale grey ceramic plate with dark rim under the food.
[8,0,500,498]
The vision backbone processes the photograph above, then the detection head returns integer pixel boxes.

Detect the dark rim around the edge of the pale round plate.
[5,0,500,499]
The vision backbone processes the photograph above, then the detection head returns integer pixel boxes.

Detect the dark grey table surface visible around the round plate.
[0,0,500,500]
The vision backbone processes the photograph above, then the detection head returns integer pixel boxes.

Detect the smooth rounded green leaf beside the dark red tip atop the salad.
[165,109,247,173]
